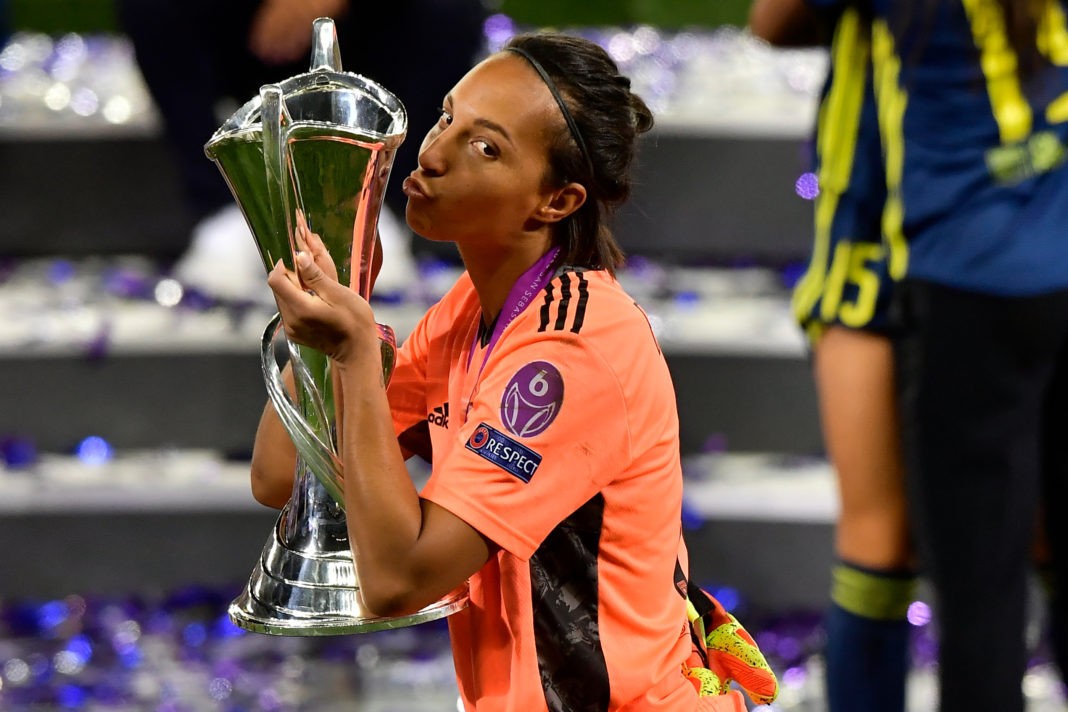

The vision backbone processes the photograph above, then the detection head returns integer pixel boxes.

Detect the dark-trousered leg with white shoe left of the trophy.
[117,0,296,304]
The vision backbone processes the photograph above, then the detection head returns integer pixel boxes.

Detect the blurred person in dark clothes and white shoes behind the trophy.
[118,0,487,303]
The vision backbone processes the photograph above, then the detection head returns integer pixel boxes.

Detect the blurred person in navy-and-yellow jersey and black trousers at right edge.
[756,0,1068,712]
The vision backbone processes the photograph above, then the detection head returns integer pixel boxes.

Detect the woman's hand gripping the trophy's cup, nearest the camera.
[267,226,381,366]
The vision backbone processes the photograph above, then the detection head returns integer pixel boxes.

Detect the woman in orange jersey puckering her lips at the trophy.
[246,34,763,712]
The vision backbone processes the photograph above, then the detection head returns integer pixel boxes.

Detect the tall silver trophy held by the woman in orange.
[204,18,467,636]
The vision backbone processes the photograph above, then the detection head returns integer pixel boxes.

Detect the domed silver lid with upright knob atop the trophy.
[204,17,408,159]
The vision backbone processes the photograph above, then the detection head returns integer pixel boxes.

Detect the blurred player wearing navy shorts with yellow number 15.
[750,0,916,712]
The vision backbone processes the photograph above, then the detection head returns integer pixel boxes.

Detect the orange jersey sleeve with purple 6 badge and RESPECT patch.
[423,325,631,559]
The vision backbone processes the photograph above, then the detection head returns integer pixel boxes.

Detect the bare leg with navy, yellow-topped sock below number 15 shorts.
[815,327,915,712]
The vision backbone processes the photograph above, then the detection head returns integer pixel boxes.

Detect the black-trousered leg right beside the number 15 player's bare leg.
[895,282,1053,712]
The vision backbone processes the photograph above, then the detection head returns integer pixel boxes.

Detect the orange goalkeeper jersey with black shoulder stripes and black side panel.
[389,257,697,712]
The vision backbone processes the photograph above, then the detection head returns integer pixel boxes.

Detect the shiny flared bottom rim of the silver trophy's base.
[227,590,467,637]
